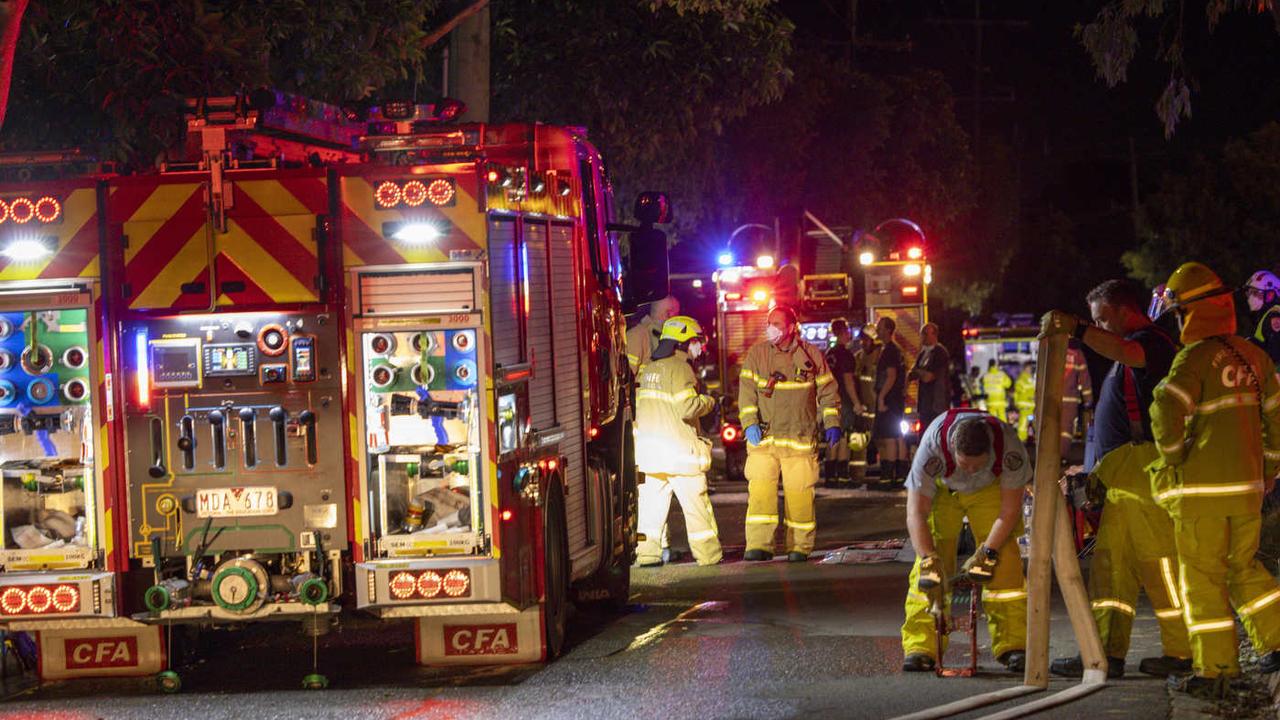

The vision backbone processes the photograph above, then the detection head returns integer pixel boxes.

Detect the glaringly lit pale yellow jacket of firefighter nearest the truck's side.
[635,350,716,475]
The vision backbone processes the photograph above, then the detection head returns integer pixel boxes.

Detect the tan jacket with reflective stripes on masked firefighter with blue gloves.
[737,340,840,454]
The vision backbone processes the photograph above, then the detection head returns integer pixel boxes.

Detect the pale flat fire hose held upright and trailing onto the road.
[897,336,1107,720]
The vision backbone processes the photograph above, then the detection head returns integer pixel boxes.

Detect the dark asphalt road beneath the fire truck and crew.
[0,488,1169,720]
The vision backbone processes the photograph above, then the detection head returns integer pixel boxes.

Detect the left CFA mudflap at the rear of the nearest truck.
[36,623,166,680]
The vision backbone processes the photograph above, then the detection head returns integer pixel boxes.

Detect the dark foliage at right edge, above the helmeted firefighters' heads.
[1123,122,1280,287]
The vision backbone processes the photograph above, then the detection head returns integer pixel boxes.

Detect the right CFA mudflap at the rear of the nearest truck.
[415,606,545,665]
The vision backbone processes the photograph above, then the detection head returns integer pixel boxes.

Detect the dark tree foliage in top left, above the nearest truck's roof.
[4,0,439,164]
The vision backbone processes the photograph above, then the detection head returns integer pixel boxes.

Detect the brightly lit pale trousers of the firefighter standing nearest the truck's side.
[636,473,723,565]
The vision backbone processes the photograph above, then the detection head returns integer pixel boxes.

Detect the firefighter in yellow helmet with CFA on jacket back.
[1149,263,1280,697]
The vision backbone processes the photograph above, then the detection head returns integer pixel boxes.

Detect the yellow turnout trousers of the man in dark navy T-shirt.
[1089,505,1192,660]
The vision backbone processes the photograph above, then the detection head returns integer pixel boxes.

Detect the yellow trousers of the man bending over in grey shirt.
[902,479,1027,660]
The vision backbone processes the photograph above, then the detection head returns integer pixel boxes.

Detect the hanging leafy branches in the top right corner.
[1075,0,1280,137]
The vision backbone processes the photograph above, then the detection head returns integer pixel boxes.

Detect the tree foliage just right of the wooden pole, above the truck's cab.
[493,0,792,231]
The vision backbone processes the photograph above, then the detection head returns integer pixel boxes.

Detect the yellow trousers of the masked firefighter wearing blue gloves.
[742,445,818,553]
